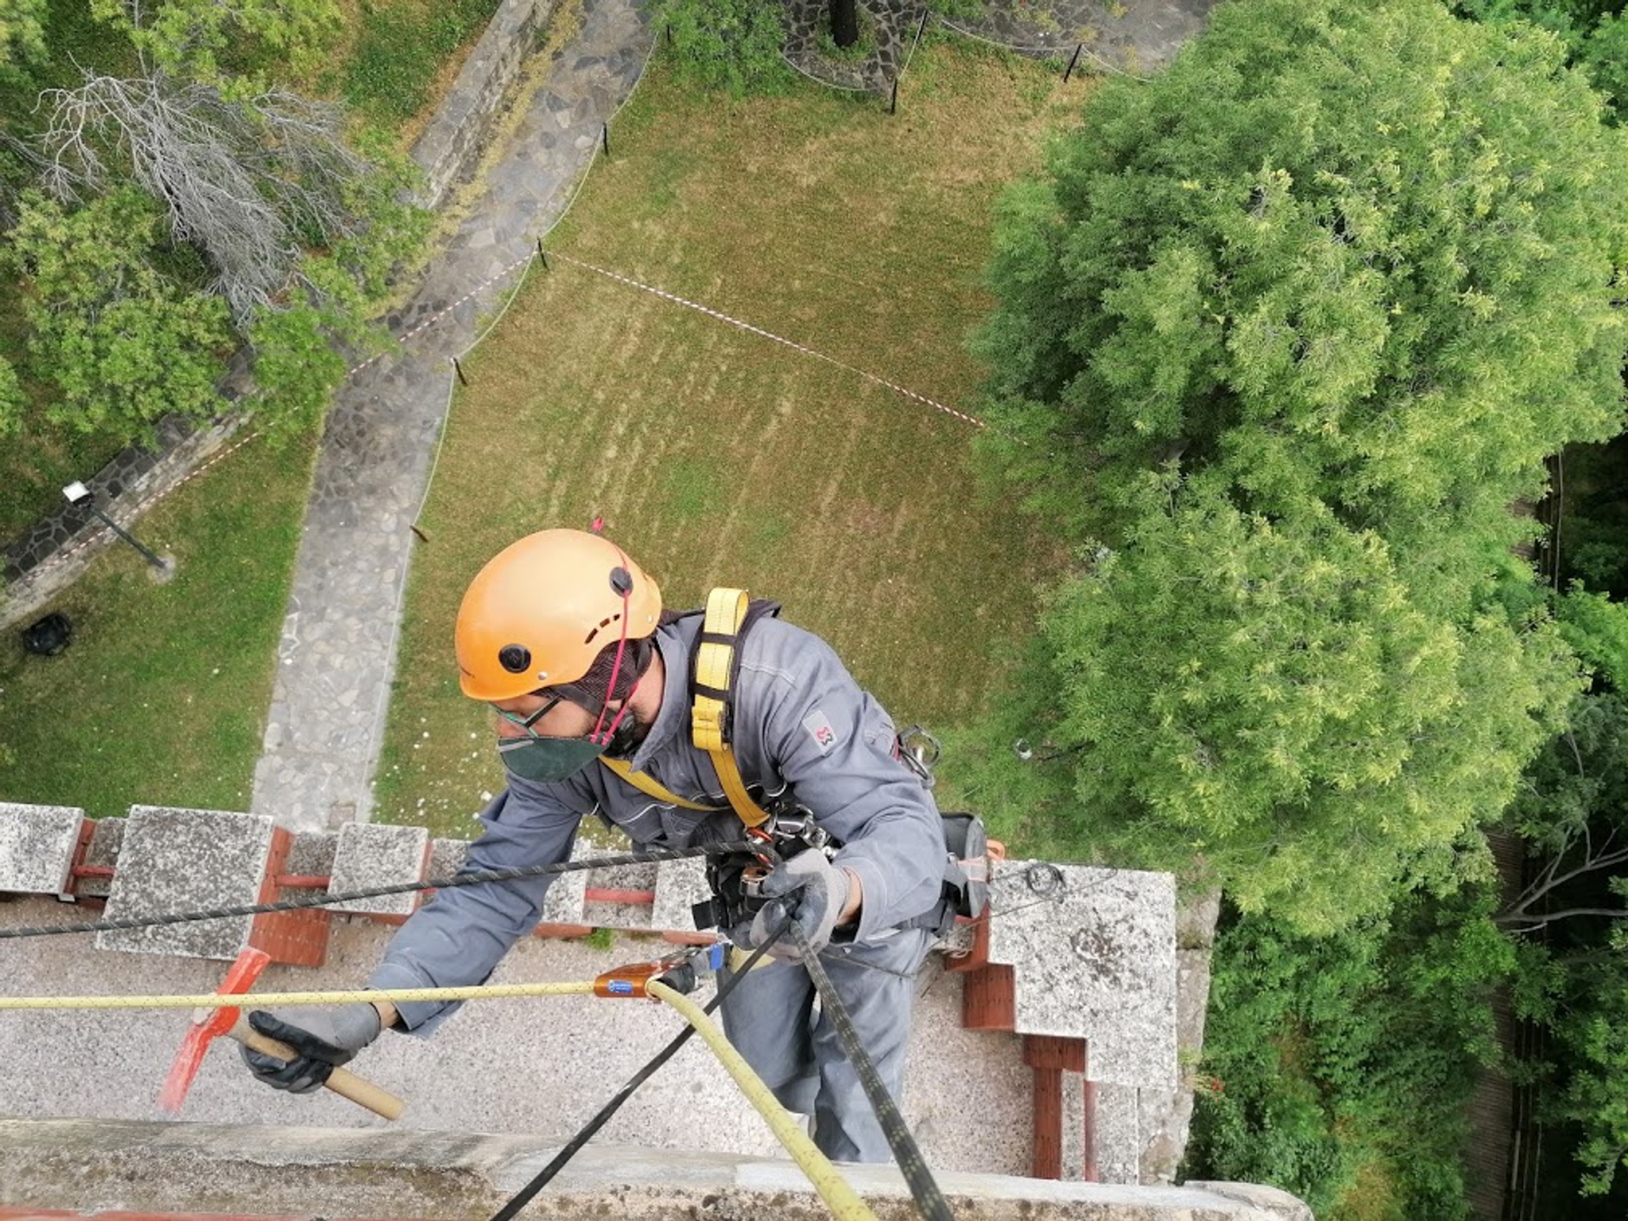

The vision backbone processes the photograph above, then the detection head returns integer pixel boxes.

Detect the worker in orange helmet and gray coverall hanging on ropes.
[244,529,946,1162]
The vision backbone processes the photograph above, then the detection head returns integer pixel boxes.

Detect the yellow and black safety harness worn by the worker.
[599,588,988,933]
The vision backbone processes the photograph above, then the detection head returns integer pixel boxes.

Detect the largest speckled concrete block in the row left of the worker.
[96,806,272,959]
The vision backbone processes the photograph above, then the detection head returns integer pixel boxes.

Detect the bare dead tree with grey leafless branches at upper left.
[39,73,376,322]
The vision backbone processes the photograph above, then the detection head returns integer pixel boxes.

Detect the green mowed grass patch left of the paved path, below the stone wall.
[0,440,313,817]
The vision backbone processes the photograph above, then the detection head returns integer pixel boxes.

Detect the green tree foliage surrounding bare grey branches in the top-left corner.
[0,0,427,466]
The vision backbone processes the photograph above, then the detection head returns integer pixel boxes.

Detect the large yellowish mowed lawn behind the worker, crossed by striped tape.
[378,42,1083,834]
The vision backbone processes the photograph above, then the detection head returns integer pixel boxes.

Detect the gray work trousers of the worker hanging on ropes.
[723,928,933,1162]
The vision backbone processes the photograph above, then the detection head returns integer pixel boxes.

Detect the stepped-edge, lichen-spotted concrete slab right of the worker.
[990,861,1175,1086]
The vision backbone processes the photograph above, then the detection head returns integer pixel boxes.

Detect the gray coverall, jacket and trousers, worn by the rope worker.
[368,615,944,1162]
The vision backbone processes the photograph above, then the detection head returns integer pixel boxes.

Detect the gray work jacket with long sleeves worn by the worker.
[368,615,944,1034]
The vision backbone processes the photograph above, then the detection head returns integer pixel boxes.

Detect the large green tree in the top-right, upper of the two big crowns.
[980,0,1628,542]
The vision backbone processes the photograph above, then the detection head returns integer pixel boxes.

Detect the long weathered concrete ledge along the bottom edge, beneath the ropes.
[0,1120,1312,1221]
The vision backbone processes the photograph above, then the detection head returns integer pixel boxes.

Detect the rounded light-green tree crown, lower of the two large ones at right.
[989,477,1574,931]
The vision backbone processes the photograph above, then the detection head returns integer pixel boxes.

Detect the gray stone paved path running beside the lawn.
[249,0,650,830]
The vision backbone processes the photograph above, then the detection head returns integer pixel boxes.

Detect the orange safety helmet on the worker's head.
[456,529,661,702]
